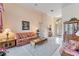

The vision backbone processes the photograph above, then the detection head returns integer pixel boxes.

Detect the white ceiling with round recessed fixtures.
[21,3,70,17]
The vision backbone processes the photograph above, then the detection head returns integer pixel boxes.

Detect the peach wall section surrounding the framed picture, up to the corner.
[3,3,42,32]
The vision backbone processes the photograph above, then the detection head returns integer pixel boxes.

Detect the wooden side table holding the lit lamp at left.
[0,39,16,48]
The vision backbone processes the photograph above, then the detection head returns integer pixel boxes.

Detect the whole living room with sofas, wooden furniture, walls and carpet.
[0,3,79,56]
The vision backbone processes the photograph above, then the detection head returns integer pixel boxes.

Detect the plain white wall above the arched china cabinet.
[62,3,79,21]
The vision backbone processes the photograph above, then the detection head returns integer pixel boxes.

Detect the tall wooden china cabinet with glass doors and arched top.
[64,18,79,41]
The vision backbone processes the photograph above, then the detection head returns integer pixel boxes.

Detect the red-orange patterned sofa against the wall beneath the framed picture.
[15,32,37,46]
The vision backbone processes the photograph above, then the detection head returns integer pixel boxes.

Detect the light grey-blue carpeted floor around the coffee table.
[7,38,59,56]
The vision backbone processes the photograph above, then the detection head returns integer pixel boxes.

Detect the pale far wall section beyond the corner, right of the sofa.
[41,14,55,37]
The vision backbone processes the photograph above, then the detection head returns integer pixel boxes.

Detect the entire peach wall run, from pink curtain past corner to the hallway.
[3,4,62,37]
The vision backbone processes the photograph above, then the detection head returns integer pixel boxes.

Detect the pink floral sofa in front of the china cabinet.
[60,40,79,56]
